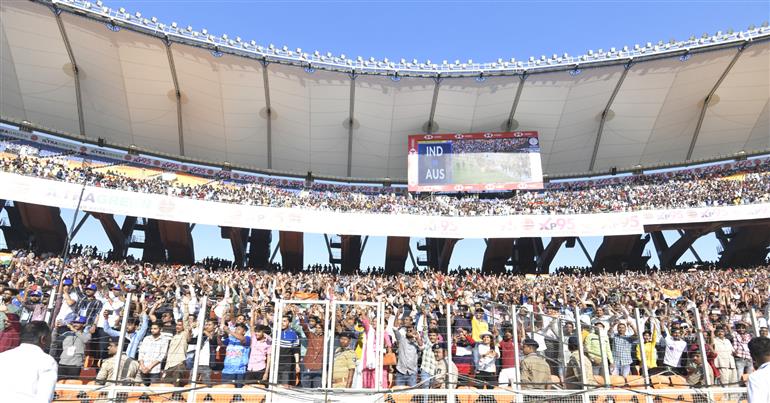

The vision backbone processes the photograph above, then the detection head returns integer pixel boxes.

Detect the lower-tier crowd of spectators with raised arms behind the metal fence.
[0,251,770,389]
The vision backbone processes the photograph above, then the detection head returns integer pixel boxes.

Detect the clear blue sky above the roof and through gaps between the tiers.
[4,0,770,272]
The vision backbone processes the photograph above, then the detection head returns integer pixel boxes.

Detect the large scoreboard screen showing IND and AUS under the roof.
[407,132,543,192]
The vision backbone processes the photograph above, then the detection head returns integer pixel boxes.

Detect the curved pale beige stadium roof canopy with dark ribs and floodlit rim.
[0,0,770,182]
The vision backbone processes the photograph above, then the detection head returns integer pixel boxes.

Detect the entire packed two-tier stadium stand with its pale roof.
[0,0,770,403]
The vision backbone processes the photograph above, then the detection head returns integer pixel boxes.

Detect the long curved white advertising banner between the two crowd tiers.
[0,172,770,238]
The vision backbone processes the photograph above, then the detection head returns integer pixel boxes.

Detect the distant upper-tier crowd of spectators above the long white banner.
[0,150,770,216]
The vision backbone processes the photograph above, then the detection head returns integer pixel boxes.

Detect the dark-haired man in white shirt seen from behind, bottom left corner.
[0,321,58,403]
